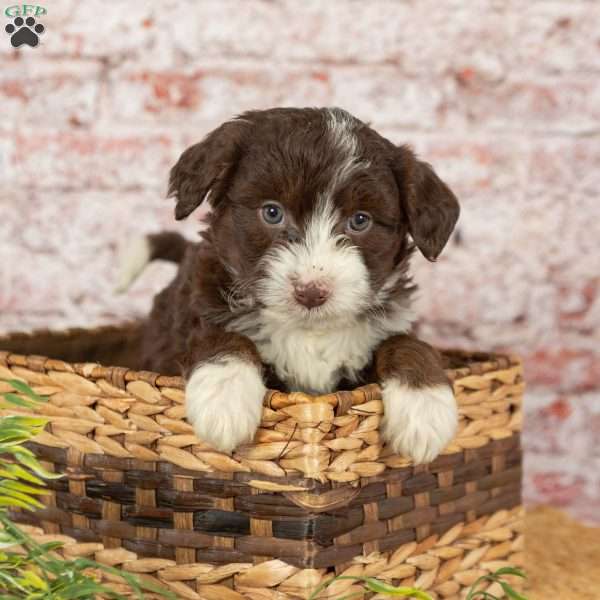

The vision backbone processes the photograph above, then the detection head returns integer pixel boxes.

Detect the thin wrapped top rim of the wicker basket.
[0,322,521,408]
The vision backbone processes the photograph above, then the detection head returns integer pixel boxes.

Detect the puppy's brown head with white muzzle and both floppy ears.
[169,109,459,323]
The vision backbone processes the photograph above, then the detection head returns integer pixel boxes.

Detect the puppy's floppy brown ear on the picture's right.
[392,146,460,261]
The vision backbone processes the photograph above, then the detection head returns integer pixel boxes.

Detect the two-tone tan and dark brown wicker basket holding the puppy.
[0,328,524,600]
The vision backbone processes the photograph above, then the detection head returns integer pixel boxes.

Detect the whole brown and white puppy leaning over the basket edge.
[120,108,459,462]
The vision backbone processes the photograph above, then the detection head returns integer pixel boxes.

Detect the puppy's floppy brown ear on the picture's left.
[168,119,248,221]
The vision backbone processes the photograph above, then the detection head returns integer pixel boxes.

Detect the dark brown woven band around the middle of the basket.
[18,434,522,568]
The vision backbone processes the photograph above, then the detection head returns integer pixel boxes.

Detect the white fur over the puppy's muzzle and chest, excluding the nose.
[227,202,414,393]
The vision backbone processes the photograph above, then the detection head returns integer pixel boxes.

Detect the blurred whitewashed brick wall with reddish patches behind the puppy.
[0,0,600,521]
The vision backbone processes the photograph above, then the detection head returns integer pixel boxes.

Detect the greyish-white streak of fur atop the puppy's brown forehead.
[325,108,370,197]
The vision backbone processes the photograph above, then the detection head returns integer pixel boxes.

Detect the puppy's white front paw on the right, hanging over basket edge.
[382,379,458,464]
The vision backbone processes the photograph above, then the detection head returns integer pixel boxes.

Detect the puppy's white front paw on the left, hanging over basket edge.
[185,356,266,452]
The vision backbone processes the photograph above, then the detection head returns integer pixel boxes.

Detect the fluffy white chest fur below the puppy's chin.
[228,315,384,393]
